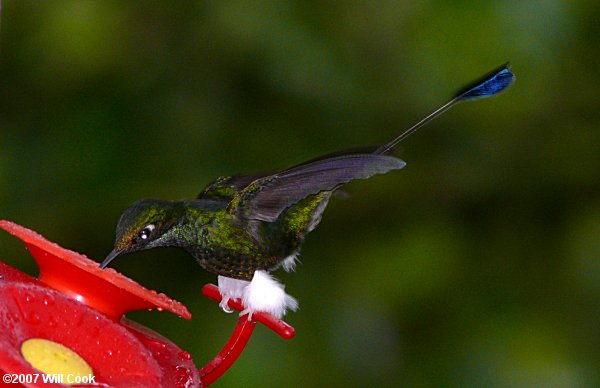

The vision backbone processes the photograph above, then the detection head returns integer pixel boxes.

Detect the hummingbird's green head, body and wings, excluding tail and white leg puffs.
[103,154,404,280]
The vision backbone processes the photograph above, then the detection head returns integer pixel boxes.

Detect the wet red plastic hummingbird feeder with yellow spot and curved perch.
[0,221,294,387]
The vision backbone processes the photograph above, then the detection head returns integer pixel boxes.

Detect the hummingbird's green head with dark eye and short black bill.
[100,199,181,268]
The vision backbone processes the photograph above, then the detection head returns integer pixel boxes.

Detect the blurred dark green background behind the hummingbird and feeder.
[0,0,600,387]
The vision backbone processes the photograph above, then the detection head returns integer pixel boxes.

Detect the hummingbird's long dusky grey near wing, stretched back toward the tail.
[227,153,405,222]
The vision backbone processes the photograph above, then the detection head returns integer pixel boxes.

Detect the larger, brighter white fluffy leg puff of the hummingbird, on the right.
[240,270,298,319]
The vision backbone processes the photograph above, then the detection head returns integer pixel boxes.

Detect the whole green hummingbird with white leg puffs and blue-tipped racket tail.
[100,63,515,319]
